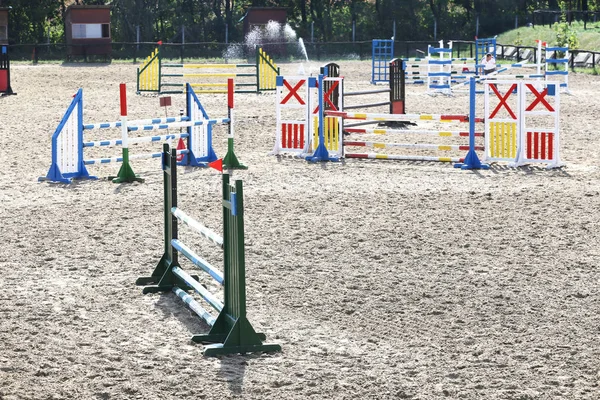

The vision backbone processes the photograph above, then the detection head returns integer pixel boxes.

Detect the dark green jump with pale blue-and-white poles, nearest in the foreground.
[136,143,281,356]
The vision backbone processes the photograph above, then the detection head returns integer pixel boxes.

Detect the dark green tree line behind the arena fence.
[0,0,600,44]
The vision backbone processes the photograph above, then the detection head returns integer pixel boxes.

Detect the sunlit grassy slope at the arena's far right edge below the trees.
[497,21,600,51]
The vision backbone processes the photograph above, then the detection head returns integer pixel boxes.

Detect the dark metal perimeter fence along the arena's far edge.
[4,40,600,71]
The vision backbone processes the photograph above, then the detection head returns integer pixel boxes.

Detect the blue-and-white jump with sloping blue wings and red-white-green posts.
[39,80,245,183]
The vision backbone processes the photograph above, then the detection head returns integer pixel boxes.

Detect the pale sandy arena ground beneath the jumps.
[0,61,600,400]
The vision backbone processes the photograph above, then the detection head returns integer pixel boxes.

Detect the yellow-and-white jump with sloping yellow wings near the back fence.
[137,47,279,94]
